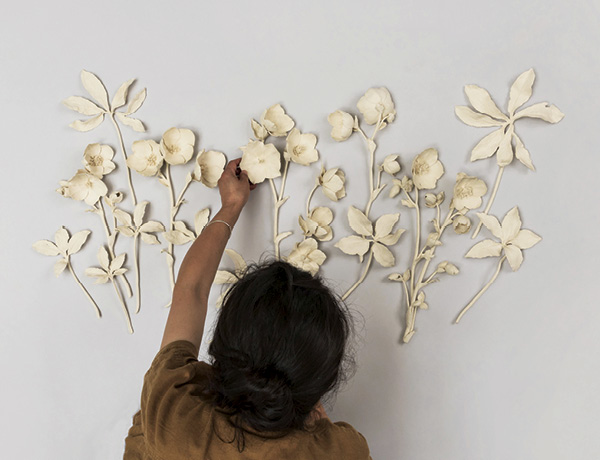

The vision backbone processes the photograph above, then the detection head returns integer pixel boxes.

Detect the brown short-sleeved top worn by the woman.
[123,340,371,460]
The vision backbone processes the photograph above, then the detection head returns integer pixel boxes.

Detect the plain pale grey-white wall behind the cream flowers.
[0,0,600,460]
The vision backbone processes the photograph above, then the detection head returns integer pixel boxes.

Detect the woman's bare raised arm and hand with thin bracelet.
[161,158,255,349]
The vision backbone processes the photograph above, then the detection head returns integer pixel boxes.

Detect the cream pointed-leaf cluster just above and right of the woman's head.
[334,206,405,267]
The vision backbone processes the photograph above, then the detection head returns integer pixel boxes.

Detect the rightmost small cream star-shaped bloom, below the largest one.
[465,206,542,271]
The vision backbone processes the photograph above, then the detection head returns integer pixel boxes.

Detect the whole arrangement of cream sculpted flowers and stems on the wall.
[34,69,563,343]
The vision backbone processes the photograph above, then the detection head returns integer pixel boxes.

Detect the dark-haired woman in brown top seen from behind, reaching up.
[124,159,370,460]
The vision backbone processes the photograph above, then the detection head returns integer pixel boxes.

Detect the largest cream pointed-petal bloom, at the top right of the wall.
[455,69,564,170]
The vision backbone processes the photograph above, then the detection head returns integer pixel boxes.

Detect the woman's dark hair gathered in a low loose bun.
[207,261,354,451]
